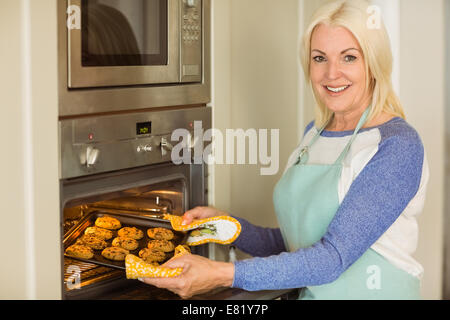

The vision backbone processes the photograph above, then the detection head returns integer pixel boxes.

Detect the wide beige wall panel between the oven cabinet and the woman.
[231,0,299,226]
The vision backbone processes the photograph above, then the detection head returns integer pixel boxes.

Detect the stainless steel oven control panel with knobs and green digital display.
[59,107,211,179]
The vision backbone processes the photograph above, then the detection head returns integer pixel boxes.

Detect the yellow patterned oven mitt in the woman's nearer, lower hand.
[125,245,190,279]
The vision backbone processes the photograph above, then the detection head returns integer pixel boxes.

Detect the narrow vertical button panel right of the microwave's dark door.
[180,0,203,82]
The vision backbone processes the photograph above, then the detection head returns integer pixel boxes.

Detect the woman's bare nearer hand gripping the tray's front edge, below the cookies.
[139,254,234,299]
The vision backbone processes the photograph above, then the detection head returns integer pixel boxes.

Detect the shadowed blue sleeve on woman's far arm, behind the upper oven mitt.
[233,217,286,257]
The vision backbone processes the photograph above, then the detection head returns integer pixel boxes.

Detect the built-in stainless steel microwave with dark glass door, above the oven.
[58,0,211,117]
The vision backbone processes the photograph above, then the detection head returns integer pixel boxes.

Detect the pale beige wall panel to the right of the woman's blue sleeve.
[400,0,445,299]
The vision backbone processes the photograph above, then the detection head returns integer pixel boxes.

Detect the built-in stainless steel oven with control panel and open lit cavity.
[59,107,211,299]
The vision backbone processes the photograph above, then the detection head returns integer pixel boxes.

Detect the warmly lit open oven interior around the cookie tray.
[62,174,202,300]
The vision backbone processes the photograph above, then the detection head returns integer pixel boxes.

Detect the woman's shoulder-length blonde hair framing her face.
[301,0,405,127]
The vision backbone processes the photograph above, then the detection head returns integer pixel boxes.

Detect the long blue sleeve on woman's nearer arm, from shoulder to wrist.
[233,124,424,291]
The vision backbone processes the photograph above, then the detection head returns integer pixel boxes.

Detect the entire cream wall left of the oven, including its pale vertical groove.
[0,0,61,299]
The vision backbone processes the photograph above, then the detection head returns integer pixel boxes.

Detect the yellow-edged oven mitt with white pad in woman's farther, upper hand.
[163,214,241,246]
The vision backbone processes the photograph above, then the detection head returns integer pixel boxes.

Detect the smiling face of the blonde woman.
[310,24,371,115]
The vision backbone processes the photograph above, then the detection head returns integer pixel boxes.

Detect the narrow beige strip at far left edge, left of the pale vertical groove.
[0,0,27,299]
